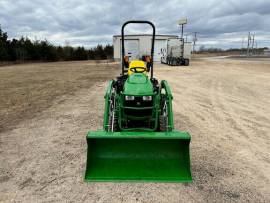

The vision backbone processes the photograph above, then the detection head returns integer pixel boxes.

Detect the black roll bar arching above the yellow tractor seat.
[121,20,156,79]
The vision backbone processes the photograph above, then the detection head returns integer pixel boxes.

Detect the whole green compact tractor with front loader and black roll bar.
[85,21,192,182]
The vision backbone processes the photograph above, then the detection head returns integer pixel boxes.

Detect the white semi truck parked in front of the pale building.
[161,38,191,66]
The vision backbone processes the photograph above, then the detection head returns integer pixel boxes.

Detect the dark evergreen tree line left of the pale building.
[0,27,113,61]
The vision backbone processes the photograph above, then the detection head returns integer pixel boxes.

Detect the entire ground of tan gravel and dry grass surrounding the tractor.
[0,59,270,202]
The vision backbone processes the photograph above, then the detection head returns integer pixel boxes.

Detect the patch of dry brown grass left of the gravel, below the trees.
[0,61,118,132]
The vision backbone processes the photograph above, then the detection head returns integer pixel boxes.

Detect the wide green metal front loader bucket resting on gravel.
[85,131,192,182]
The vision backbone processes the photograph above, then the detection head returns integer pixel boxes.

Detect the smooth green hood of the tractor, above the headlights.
[123,73,153,96]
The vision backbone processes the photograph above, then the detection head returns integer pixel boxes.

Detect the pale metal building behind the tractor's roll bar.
[113,34,178,62]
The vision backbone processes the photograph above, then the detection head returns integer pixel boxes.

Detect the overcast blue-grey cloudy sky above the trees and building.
[0,0,270,48]
